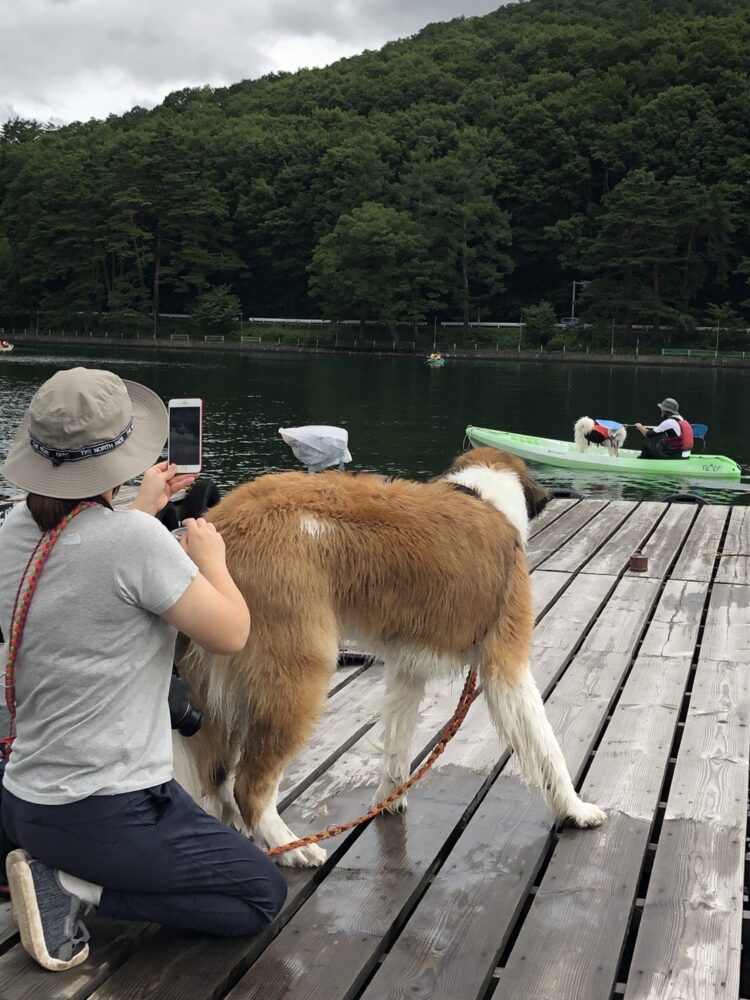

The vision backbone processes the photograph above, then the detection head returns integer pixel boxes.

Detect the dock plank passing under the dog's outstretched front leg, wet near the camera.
[363,581,658,1000]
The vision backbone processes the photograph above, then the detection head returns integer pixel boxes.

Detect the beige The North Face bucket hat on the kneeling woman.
[0,368,167,500]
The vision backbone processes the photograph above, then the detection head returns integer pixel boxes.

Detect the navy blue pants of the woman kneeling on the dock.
[2,781,286,935]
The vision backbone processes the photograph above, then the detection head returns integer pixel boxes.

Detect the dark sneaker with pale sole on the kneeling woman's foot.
[5,850,89,972]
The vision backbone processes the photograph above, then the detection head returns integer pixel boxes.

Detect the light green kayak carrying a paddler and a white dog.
[466,425,742,479]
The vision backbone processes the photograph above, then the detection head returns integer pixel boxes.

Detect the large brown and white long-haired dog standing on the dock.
[175,448,604,865]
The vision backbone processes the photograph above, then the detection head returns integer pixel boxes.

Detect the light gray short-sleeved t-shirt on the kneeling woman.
[0,503,198,805]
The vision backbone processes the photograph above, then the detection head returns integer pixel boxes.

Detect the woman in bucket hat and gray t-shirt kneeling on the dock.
[0,368,286,970]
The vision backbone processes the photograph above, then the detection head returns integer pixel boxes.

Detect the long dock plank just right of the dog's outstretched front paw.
[498,581,708,1000]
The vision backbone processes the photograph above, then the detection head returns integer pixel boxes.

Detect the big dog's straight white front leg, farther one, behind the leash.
[372,667,425,812]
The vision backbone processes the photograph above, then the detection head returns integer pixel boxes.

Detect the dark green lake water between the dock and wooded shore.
[0,348,750,503]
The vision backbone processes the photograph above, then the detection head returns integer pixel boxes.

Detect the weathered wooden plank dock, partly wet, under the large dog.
[0,500,750,1000]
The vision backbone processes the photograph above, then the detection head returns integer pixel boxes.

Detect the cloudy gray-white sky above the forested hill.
[0,0,507,122]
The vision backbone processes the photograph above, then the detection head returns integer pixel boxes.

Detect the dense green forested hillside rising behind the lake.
[0,0,750,342]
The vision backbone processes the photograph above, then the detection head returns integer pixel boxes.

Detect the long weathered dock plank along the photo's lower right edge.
[625,585,750,1000]
